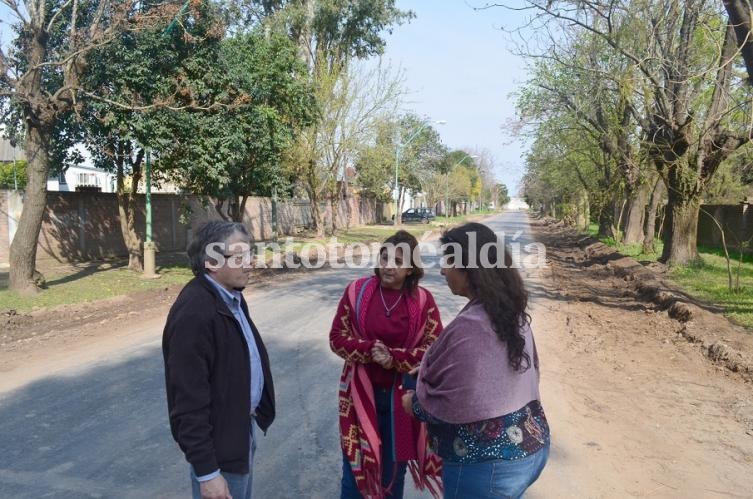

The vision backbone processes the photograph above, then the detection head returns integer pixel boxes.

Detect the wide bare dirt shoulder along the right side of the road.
[529,221,753,499]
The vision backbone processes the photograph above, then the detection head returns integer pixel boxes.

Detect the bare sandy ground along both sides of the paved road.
[0,223,753,499]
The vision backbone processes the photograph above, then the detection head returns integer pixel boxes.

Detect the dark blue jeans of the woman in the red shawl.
[340,388,407,499]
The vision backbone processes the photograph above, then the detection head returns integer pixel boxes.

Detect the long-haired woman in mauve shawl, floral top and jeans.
[402,223,550,499]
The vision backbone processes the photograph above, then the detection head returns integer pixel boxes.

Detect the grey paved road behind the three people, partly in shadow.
[0,212,531,499]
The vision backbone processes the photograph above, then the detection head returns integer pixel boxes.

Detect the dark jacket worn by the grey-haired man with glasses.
[162,276,275,476]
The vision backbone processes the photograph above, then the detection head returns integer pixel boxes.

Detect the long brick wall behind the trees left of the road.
[0,190,381,265]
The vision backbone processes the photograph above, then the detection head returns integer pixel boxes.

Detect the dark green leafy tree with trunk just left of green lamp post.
[79,2,226,272]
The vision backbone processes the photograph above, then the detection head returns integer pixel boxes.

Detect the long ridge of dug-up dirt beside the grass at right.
[531,219,753,381]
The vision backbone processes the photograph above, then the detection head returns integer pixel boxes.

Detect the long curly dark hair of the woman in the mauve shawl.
[440,222,531,371]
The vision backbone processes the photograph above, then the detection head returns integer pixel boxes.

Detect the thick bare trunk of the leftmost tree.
[10,125,50,293]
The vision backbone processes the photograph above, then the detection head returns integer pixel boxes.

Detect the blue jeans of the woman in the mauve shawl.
[442,443,549,499]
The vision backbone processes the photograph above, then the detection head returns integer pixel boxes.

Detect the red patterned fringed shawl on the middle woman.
[329,276,442,499]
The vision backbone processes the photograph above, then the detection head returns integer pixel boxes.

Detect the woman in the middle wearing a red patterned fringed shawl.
[329,230,442,499]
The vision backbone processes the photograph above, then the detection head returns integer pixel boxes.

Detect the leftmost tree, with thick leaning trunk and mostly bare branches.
[0,0,187,292]
